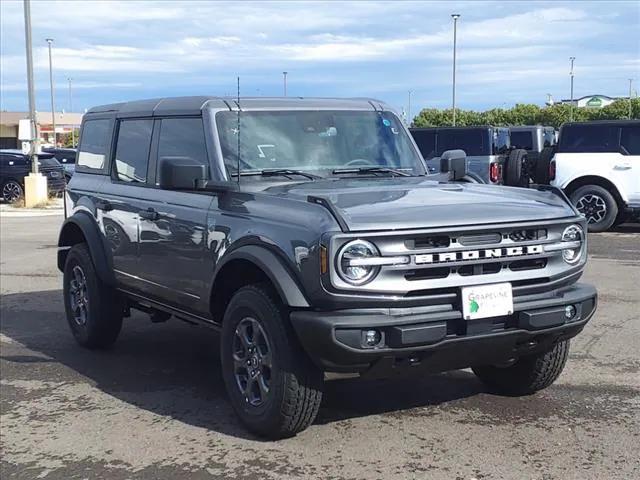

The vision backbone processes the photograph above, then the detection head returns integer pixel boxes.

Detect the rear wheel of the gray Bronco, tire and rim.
[63,243,123,349]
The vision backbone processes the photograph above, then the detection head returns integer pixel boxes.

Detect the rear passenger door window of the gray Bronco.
[115,119,153,183]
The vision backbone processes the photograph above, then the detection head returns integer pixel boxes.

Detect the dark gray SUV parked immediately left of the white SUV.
[509,125,557,184]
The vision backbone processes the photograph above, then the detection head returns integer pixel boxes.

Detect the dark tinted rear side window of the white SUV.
[558,124,620,153]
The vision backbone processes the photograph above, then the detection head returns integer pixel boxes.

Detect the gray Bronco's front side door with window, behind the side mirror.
[139,117,215,316]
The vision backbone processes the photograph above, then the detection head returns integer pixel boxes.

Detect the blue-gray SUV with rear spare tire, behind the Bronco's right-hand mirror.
[410,126,528,186]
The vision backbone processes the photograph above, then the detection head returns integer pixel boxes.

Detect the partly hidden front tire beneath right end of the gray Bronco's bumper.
[473,340,569,396]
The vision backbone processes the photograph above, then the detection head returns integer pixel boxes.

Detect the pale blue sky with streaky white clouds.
[0,0,640,115]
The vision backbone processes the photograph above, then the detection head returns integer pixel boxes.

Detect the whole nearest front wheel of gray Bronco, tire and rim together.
[220,284,323,438]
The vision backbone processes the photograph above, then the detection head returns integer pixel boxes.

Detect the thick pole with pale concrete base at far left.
[23,0,47,204]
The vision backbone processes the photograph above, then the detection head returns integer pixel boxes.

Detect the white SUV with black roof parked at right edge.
[549,120,640,232]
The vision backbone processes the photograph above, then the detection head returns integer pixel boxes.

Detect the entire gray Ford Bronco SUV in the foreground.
[58,97,597,438]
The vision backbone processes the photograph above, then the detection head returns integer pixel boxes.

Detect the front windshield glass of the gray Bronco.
[216,111,425,175]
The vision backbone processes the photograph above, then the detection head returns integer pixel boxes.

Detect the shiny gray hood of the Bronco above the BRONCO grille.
[262,177,575,232]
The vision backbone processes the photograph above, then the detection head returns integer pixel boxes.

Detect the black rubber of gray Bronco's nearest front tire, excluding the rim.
[220,284,323,439]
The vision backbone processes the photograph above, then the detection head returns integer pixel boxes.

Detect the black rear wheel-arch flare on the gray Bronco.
[58,210,115,285]
